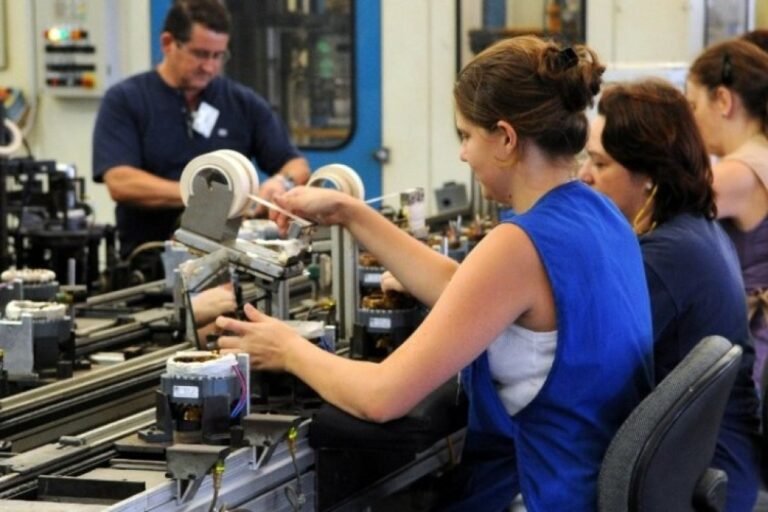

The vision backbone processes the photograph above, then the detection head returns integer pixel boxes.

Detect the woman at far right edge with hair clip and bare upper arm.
[686,39,768,388]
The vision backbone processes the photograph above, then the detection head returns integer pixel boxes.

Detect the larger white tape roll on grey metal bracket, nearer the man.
[179,149,259,218]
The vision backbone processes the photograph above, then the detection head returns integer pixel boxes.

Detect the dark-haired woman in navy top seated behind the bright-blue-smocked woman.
[580,80,760,512]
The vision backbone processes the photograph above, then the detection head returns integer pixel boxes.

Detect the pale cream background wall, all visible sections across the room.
[0,0,768,226]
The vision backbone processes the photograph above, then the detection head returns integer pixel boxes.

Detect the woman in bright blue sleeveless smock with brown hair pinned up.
[217,36,653,512]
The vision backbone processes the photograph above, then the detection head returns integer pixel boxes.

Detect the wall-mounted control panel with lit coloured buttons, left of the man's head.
[35,0,122,97]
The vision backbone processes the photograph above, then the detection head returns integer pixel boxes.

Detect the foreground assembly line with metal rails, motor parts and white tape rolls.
[0,152,464,511]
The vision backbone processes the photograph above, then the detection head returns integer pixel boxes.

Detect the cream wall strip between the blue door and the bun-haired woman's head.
[382,0,464,213]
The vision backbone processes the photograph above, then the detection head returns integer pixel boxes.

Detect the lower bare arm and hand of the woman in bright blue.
[217,225,555,422]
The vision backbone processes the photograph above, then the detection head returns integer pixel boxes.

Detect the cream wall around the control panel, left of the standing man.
[0,0,150,223]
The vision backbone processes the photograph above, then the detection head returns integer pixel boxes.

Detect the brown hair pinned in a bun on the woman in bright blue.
[453,36,605,157]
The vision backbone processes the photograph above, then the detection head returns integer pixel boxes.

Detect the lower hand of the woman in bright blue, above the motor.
[216,304,306,371]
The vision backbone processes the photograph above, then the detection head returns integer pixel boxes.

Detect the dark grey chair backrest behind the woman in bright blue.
[598,336,741,512]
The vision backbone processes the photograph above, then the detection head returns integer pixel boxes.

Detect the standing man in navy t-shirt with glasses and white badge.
[93,0,310,258]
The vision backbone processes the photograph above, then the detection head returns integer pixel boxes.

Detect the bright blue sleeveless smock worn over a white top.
[460,181,653,512]
